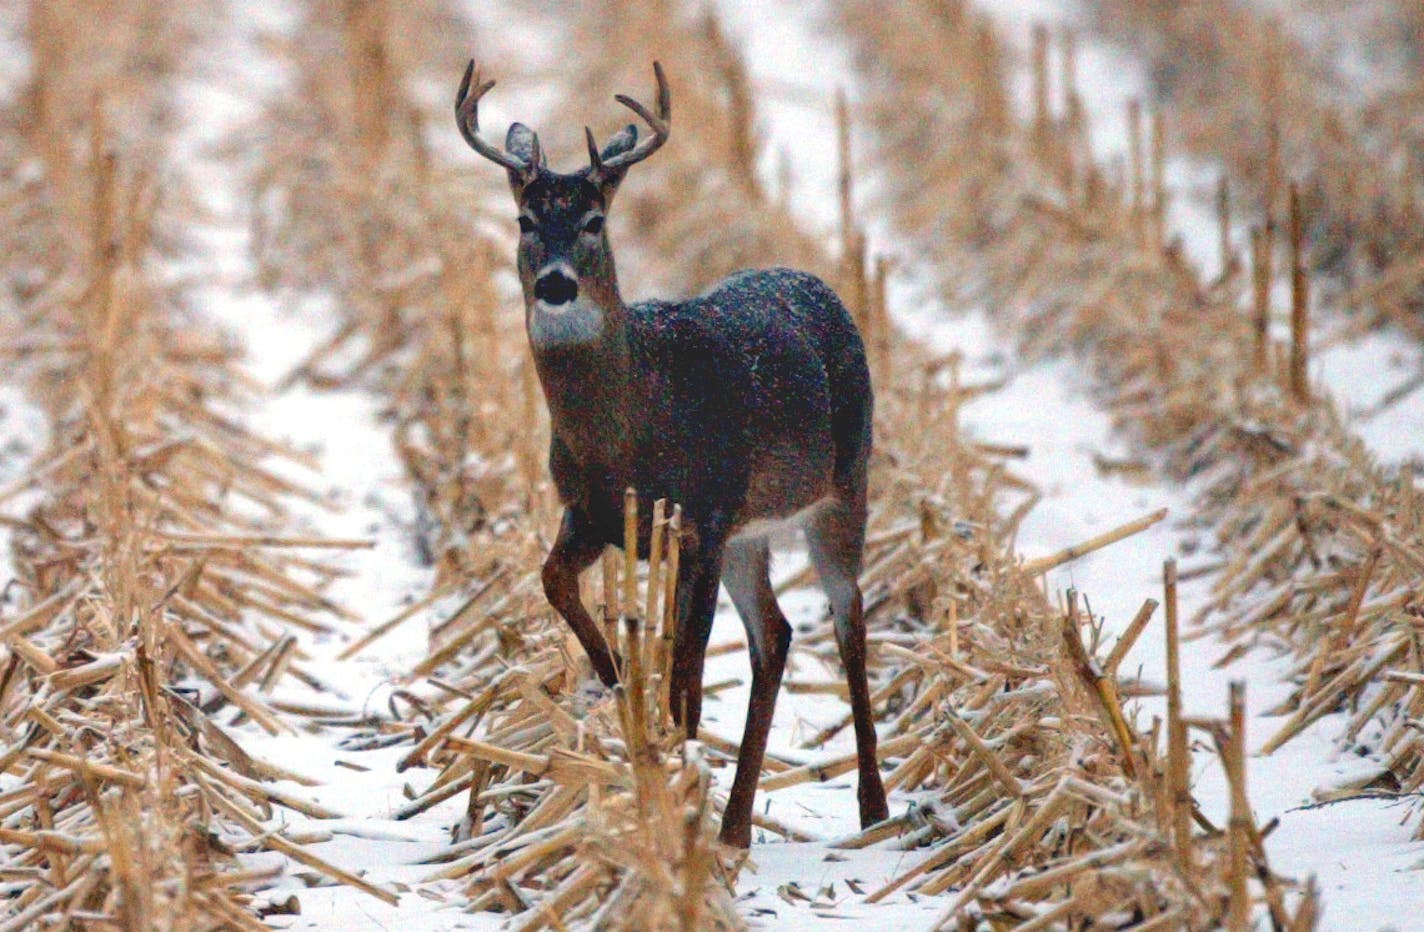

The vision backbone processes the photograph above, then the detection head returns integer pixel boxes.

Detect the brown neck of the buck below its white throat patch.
[528,281,638,467]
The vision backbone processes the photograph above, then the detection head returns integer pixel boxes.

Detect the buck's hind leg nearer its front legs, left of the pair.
[722,537,792,848]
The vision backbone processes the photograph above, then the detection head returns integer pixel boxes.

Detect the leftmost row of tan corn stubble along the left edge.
[0,1,393,929]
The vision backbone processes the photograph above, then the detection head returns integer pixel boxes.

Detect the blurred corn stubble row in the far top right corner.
[1092,0,1424,329]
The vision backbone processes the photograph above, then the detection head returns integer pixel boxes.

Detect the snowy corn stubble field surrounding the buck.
[0,0,1424,929]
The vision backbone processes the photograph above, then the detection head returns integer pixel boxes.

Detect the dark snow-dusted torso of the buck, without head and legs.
[533,269,843,546]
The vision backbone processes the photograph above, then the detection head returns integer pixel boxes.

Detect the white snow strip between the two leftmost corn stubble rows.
[168,4,500,932]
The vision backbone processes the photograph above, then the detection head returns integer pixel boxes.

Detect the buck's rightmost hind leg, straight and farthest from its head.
[806,499,890,828]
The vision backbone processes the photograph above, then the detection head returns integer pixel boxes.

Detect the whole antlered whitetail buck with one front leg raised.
[456,61,887,848]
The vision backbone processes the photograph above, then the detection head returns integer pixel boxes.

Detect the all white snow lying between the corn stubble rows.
[108,0,1424,931]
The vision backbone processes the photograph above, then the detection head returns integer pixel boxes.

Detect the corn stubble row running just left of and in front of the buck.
[246,3,757,928]
